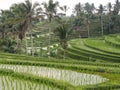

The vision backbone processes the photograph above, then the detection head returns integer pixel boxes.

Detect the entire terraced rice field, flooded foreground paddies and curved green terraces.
[0,35,120,90]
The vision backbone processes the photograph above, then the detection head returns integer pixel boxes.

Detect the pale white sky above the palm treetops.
[0,0,116,15]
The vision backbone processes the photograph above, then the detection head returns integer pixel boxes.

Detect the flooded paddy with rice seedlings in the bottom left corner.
[0,76,60,90]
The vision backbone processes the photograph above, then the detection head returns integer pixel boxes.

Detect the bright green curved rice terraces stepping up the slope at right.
[67,35,120,62]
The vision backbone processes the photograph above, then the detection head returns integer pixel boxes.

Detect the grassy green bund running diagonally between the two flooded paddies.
[0,69,73,90]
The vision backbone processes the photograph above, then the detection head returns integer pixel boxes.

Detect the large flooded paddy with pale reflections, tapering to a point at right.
[0,64,107,86]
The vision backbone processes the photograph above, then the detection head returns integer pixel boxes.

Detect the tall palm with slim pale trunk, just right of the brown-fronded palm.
[21,0,42,56]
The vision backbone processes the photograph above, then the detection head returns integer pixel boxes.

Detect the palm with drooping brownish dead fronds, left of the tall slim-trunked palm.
[10,3,28,51]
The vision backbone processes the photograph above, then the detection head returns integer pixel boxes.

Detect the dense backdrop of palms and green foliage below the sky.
[0,0,120,54]
